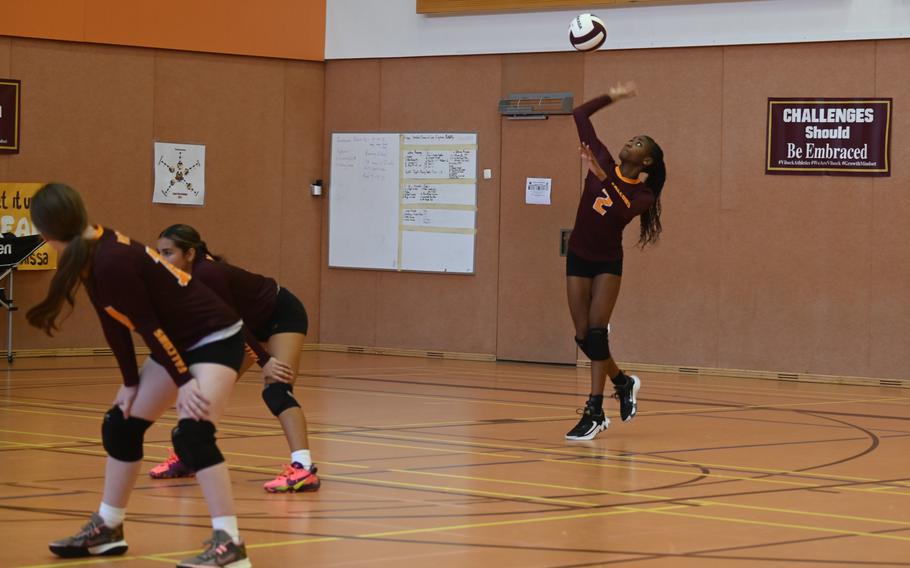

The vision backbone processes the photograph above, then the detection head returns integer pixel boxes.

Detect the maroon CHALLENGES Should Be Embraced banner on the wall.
[765,98,892,176]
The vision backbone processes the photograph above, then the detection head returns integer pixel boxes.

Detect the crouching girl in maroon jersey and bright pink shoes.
[150,224,320,493]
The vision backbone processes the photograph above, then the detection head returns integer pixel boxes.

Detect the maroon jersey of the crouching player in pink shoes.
[193,255,278,367]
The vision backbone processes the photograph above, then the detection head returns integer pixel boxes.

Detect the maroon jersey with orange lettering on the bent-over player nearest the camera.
[85,227,240,386]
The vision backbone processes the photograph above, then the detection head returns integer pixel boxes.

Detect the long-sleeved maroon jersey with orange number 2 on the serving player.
[569,95,654,262]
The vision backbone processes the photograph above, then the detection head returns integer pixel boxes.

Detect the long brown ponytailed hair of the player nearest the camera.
[25,183,98,335]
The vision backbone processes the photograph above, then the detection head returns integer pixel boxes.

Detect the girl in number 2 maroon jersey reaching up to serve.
[566,83,667,440]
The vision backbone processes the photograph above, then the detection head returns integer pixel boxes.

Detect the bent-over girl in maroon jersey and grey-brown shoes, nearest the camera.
[27,184,251,568]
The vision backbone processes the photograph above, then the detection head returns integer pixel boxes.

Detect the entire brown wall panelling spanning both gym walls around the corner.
[0,38,910,378]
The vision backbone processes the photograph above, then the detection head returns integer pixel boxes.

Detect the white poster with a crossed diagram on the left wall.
[152,142,205,205]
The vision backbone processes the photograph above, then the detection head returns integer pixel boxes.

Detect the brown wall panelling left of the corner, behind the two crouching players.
[0,38,324,349]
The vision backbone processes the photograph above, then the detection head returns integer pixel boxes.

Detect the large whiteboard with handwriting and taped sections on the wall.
[328,132,477,274]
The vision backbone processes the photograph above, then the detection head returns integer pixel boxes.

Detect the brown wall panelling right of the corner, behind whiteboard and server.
[322,40,910,377]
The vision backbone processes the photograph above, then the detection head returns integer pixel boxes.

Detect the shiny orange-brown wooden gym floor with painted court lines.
[0,352,910,568]
